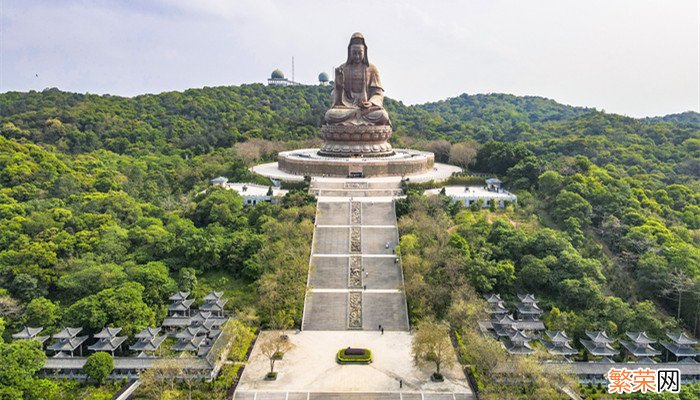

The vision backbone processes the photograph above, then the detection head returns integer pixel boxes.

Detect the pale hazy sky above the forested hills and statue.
[0,0,700,117]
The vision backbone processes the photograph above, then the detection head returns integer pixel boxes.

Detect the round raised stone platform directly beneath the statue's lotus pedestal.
[277,149,435,178]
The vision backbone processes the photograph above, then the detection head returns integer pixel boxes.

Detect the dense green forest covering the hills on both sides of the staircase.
[0,84,700,399]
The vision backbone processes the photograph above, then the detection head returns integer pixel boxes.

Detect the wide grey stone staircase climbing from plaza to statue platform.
[302,181,409,331]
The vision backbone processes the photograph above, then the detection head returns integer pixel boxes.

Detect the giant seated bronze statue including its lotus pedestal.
[319,32,393,157]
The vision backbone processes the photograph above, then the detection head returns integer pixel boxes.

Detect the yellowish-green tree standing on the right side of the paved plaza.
[411,319,454,380]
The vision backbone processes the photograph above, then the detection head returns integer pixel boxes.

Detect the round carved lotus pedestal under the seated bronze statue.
[318,125,394,157]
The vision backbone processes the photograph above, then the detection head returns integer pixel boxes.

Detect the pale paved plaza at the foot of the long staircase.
[234,331,472,400]
